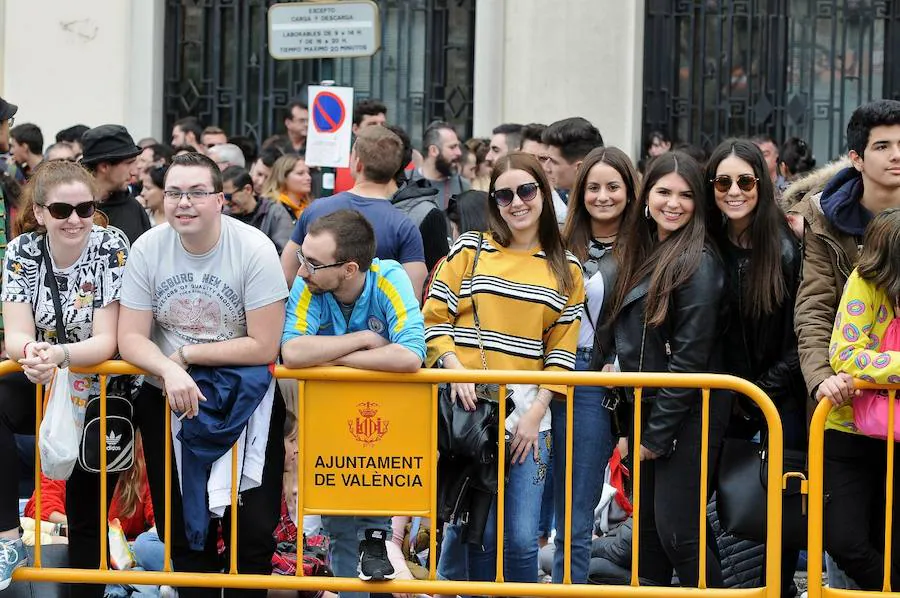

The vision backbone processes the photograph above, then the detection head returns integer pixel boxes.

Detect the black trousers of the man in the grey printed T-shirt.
[135,384,285,598]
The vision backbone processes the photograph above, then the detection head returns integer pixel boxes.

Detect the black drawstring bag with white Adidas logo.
[78,376,134,473]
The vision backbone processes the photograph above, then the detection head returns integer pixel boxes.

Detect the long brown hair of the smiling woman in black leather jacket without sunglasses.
[612,152,707,326]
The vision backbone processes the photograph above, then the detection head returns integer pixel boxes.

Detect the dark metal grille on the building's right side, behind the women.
[643,0,900,163]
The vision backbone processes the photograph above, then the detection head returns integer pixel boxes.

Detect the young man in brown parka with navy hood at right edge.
[786,100,900,589]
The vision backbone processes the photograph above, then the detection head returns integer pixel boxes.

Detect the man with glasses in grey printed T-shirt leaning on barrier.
[118,153,288,598]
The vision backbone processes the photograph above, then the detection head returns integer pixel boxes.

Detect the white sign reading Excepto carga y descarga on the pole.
[269,0,381,60]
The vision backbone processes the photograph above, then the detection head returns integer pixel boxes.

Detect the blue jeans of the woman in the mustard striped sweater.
[438,430,552,583]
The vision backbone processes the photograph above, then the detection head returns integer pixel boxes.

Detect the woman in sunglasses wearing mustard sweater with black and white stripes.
[423,152,584,582]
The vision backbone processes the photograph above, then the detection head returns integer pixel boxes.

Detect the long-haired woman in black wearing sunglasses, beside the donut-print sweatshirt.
[706,139,806,596]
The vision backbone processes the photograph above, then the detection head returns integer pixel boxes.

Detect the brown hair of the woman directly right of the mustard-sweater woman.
[562,147,640,262]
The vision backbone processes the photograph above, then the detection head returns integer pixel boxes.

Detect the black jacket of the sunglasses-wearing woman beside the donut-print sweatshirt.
[721,227,806,418]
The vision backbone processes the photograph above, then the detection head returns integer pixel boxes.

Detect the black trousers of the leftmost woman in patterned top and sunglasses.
[0,373,118,598]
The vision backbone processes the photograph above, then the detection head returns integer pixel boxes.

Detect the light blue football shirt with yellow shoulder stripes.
[281,258,425,360]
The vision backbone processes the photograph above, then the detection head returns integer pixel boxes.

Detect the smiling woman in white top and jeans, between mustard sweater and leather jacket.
[550,147,639,583]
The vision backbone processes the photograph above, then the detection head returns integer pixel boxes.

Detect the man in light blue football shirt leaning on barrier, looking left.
[281,210,425,598]
